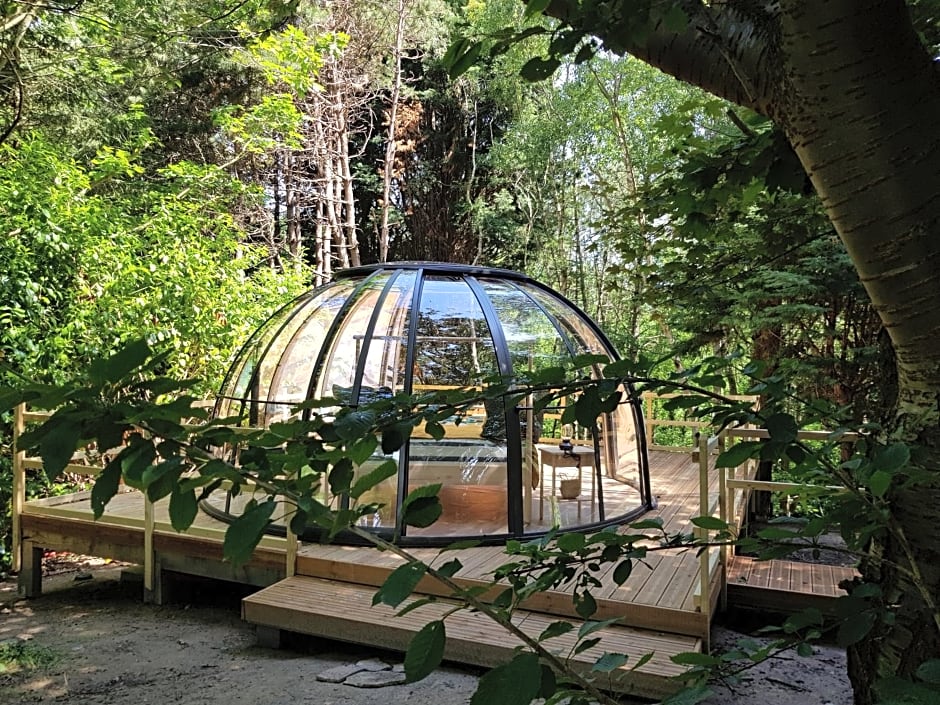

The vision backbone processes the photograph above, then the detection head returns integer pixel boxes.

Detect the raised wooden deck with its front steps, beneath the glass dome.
[12,451,852,698]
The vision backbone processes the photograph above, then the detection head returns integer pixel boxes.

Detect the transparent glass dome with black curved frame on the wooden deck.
[206,262,651,545]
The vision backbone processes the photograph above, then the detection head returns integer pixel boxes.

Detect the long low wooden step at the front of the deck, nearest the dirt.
[242,575,701,699]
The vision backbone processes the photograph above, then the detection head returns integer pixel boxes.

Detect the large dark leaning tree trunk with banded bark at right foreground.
[549,0,940,705]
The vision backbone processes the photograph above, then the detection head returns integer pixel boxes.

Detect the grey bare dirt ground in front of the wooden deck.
[0,565,851,705]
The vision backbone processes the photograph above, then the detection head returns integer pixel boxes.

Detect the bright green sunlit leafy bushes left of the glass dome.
[0,135,300,391]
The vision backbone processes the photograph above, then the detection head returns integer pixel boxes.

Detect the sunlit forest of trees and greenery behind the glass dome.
[0,0,938,700]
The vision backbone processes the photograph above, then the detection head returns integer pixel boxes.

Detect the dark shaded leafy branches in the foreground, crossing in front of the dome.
[7,341,940,704]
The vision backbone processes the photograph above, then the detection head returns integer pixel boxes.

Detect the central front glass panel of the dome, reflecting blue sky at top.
[408,276,509,536]
